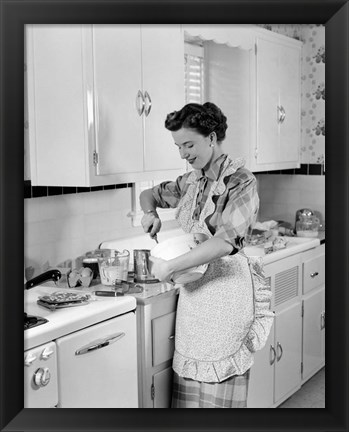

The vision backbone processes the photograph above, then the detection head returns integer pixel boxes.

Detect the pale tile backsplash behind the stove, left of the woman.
[24,188,178,279]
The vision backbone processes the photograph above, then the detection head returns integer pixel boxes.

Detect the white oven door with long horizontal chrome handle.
[56,312,138,408]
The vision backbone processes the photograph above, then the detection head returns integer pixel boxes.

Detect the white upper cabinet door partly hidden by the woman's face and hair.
[141,25,185,171]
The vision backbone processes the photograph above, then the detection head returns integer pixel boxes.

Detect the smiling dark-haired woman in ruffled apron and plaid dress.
[140,102,273,408]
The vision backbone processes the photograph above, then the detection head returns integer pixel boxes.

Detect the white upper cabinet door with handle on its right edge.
[92,24,143,175]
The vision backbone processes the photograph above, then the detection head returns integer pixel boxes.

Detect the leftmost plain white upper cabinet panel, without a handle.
[25,24,88,186]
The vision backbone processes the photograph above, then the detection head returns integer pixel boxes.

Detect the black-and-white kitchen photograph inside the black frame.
[1,2,348,431]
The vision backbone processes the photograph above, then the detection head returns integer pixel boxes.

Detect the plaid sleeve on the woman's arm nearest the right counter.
[215,170,259,252]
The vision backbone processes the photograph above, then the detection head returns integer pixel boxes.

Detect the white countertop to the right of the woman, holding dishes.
[244,236,320,264]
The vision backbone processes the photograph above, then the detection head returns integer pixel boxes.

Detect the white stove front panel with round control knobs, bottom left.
[24,342,58,408]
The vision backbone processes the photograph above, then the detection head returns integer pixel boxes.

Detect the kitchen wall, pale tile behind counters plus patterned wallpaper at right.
[24,24,325,279]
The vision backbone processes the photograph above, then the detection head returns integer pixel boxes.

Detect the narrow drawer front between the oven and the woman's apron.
[151,312,176,366]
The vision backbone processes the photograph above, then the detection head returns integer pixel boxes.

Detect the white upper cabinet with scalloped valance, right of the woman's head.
[184,25,302,172]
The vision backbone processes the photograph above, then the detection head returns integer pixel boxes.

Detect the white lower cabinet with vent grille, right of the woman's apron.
[247,244,325,408]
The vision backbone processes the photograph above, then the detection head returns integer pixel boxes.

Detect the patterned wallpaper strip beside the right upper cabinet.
[260,24,325,164]
